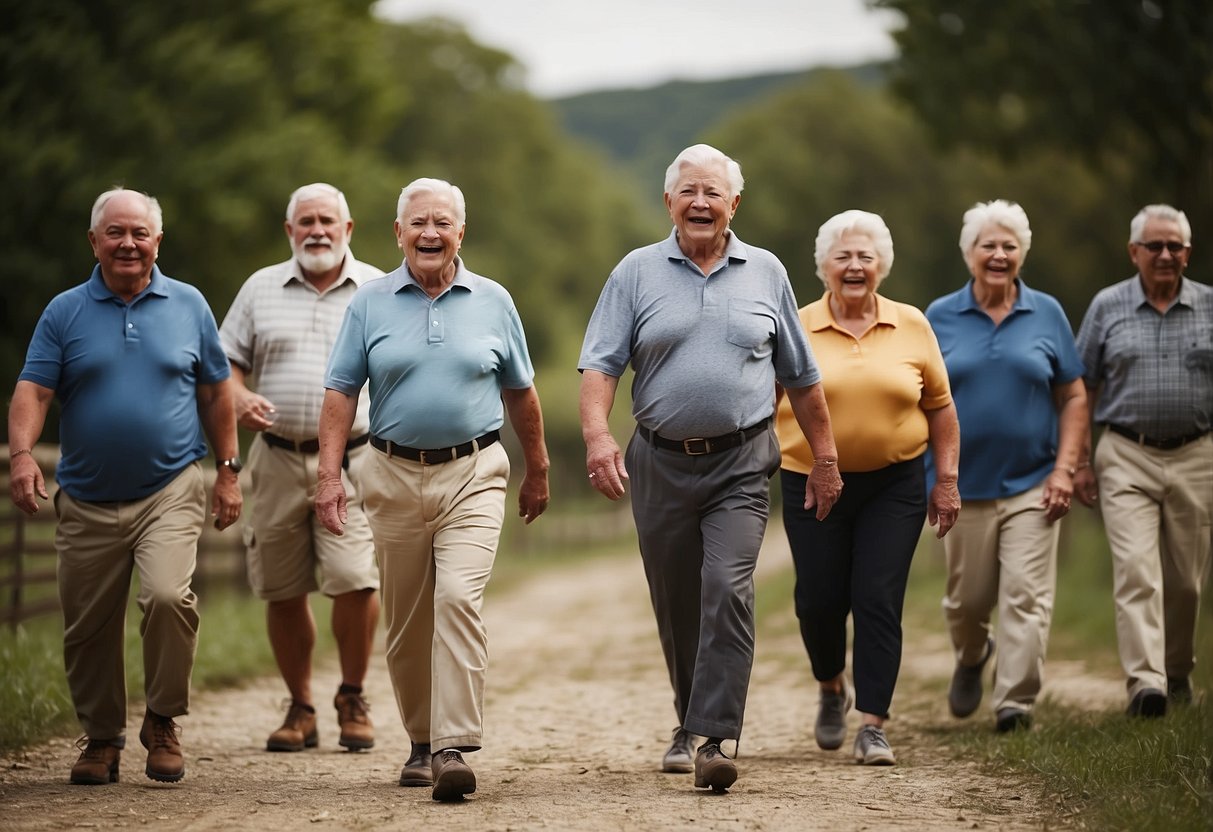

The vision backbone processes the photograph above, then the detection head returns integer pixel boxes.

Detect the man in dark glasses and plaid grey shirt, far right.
[1075,205,1213,717]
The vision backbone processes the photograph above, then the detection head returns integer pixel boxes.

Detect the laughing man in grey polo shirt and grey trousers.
[577,144,842,792]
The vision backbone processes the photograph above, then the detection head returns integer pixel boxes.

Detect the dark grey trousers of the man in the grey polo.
[625,431,780,740]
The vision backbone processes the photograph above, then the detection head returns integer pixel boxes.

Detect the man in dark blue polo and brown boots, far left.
[8,188,241,785]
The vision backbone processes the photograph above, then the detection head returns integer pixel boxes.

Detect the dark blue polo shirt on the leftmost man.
[21,266,232,502]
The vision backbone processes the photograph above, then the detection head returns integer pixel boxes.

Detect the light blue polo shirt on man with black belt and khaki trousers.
[324,260,535,448]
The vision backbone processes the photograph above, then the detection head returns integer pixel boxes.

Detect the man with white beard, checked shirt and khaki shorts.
[220,183,383,751]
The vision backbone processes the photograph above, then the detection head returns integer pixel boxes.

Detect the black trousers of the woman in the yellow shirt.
[780,457,927,717]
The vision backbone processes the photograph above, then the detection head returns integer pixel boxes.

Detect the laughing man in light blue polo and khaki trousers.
[315,178,548,800]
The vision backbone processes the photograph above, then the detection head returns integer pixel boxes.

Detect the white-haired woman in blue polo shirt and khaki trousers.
[927,199,1087,731]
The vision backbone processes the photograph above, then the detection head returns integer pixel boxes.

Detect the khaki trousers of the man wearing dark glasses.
[1094,431,1213,697]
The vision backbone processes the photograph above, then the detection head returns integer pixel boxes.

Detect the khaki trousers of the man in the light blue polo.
[361,443,509,751]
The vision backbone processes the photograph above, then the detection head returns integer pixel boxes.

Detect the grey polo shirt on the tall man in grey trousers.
[577,230,821,439]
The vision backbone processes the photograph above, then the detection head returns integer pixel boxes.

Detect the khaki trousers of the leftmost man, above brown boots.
[55,462,206,745]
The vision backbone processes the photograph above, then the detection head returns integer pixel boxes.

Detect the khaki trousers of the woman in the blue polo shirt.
[944,485,1061,712]
